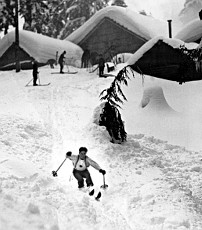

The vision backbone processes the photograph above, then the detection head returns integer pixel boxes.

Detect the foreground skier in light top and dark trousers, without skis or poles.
[66,147,106,188]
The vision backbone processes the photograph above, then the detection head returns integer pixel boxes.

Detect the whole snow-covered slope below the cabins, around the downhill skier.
[0,64,202,230]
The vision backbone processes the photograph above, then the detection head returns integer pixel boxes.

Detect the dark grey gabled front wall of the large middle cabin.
[78,18,146,62]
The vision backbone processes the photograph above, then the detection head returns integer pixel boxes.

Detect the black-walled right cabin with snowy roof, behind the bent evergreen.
[127,37,202,83]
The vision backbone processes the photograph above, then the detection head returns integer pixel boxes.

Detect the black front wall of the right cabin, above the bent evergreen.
[132,40,201,83]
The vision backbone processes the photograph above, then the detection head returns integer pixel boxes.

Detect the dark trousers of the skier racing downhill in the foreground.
[73,169,93,188]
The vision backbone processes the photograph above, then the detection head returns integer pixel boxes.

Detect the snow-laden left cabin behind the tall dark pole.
[0,30,83,70]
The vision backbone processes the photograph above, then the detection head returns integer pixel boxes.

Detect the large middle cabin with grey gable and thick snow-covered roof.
[66,6,169,63]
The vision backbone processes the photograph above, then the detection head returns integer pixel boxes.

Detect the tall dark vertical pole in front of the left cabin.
[15,0,20,72]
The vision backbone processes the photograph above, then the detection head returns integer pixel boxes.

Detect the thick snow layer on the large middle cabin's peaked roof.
[66,6,168,44]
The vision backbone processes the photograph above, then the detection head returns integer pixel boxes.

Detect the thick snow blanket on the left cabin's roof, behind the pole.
[0,30,83,64]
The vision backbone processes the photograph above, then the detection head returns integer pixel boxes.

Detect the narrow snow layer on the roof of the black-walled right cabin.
[127,36,198,65]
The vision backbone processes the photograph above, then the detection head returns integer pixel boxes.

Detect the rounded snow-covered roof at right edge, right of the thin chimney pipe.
[175,19,202,42]
